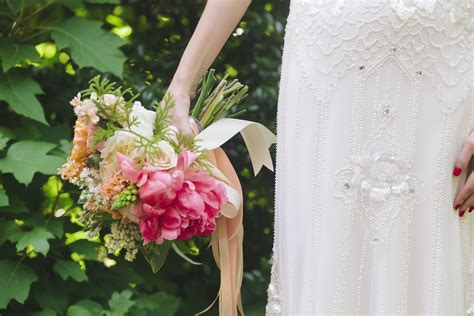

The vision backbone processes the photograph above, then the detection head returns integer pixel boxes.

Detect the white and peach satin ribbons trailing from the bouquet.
[196,118,276,316]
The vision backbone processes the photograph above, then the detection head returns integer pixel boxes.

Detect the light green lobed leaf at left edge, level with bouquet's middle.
[0,140,64,185]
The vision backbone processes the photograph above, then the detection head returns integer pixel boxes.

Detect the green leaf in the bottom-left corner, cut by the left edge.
[0,260,38,309]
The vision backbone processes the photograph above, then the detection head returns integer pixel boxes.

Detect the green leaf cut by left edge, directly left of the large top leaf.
[0,39,41,72]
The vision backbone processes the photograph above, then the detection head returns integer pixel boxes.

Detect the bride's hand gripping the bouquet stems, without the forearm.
[167,83,193,134]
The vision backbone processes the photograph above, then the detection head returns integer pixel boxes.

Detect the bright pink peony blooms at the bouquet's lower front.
[117,151,228,244]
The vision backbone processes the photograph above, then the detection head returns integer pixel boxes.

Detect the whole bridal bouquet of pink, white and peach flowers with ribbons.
[59,70,275,316]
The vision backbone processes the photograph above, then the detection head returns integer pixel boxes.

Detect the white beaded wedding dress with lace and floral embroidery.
[266,0,474,316]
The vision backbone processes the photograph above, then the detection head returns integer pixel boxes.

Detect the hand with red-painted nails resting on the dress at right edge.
[453,131,474,217]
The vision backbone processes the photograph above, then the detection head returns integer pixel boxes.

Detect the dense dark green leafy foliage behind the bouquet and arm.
[0,0,288,316]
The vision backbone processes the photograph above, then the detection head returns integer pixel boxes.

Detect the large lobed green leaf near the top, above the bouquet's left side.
[51,17,126,77]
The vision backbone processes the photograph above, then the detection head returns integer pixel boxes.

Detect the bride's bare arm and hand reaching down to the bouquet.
[168,0,251,133]
